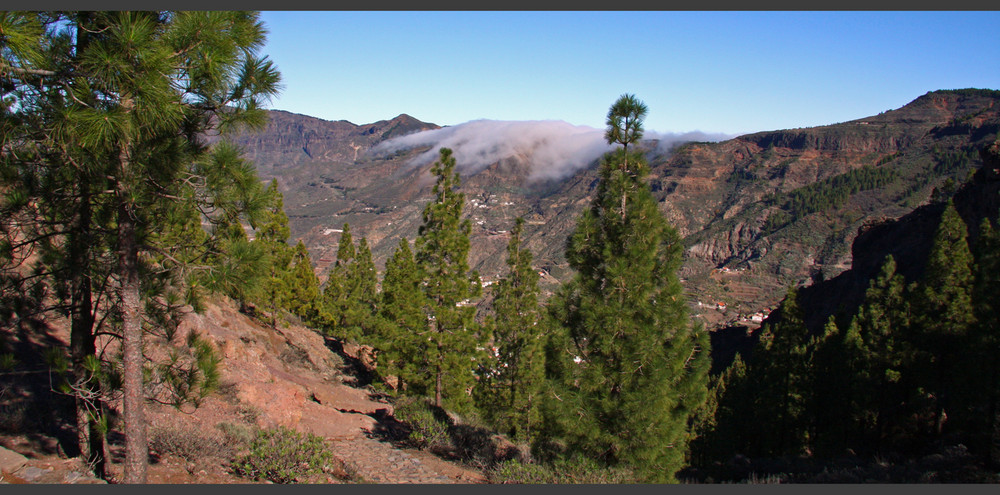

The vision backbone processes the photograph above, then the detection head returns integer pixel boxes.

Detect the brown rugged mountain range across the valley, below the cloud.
[227,89,1000,327]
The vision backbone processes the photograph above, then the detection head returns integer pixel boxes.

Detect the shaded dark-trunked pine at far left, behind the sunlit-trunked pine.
[0,12,114,476]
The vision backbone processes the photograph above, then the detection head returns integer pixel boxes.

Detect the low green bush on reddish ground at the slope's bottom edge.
[233,427,333,483]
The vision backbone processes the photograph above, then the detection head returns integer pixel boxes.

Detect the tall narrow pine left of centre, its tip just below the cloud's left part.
[414,148,489,413]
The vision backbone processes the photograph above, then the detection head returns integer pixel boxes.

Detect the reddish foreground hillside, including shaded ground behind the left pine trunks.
[0,298,482,484]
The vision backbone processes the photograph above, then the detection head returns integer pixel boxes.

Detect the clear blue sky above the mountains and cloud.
[261,11,1000,134]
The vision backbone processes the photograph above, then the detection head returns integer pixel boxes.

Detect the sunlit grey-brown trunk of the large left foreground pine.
[118,147,148,483]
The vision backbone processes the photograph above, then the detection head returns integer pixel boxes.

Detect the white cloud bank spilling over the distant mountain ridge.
[372,120,727,180]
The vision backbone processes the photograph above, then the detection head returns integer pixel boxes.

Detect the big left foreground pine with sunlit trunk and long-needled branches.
[0,12,278,483]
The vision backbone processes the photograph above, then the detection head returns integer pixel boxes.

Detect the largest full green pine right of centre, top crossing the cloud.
[550,95,710,481]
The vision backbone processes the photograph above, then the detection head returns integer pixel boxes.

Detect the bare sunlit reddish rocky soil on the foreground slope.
[0,300,484,484]
